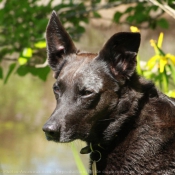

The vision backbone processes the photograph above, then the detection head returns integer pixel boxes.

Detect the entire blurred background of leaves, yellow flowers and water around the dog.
[0,0,175,175]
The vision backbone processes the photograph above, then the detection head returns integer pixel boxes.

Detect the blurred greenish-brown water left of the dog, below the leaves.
[0,75,88,175]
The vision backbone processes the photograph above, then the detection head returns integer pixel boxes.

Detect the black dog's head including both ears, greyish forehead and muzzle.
[43,12,140,142]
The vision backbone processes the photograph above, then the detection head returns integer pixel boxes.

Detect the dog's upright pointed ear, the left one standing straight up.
[46,11,77,71]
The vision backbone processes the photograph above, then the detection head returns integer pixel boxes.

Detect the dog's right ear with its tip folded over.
[98,32,140,81]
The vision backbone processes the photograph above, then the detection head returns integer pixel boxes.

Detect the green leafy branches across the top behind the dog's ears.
[0,0,175,83]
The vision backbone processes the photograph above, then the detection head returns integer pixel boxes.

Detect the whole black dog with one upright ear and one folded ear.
[43,12,175,175]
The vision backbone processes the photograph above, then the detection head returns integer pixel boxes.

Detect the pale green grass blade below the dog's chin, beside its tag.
[71,143,88,175]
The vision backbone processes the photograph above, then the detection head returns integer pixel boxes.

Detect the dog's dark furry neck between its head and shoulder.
[87,76,158,151]
